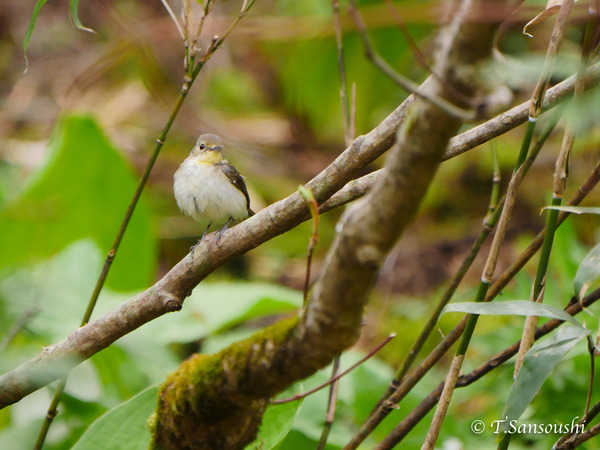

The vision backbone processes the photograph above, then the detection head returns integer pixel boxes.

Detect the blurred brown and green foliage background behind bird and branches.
[0,0,600,449]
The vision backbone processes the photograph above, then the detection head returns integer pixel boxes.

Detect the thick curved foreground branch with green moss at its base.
[152,0,502,449]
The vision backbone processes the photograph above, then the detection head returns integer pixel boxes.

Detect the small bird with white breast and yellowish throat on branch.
[173,134,254,248]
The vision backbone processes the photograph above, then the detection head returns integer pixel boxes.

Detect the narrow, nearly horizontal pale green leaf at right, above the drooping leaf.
[440,300,583,328]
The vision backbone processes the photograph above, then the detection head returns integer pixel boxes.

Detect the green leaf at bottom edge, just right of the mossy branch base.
[246,384,302,450]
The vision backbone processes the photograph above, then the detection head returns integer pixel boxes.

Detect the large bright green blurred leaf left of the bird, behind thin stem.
[0,115,156,292]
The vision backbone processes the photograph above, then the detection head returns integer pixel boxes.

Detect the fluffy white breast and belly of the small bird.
[173,157,248,229]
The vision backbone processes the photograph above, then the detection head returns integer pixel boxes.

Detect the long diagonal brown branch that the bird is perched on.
[0,12,600,409]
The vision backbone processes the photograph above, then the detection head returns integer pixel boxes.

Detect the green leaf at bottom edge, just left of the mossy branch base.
[72,386,158,450]
